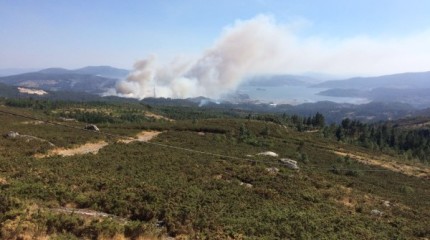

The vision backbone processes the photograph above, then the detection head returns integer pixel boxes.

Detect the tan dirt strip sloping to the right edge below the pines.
[333,151,430,179]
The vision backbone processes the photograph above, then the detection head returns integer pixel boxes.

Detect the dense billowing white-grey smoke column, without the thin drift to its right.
[117,16,288,98]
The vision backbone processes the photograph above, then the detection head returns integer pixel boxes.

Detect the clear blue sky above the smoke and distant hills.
[0,0,430,72]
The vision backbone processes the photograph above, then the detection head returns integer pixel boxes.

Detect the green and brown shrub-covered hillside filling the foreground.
[0,100,430,239]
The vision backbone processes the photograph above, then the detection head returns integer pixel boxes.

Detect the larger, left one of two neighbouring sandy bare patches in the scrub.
[35,141,108,158]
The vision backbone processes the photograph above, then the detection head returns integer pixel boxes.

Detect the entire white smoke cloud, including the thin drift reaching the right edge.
[116,15,430,98]
